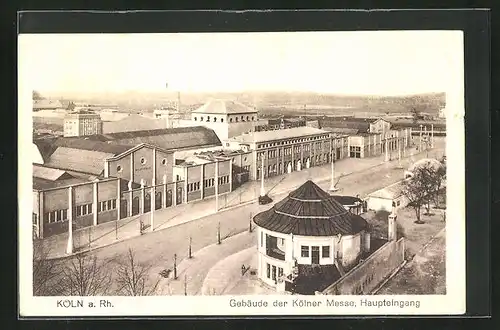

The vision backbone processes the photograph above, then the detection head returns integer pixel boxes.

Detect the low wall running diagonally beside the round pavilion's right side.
[320,238,405,295]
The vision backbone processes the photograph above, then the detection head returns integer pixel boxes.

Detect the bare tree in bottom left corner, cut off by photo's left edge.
[33,240,60,296]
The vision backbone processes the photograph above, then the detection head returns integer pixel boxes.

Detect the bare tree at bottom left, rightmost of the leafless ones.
[115,249,160,296]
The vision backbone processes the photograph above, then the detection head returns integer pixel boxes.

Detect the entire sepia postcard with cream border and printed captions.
[18,31,465,316]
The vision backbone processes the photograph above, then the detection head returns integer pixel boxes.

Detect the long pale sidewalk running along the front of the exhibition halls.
[44,143,443,258]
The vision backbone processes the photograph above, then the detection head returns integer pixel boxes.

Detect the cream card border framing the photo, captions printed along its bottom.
[18,31,466,317]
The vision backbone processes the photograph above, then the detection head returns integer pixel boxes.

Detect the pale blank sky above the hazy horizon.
[19,31,463,95]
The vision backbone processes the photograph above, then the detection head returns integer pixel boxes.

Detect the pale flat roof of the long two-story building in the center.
[232,126,328,143]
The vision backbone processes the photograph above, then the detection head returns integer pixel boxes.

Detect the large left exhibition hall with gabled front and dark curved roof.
[33,127,232,238]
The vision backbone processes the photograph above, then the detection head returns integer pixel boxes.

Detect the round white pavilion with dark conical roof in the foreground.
[254,181,370,294]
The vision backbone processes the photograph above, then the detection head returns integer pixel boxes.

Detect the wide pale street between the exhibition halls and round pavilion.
[47,138,442,294]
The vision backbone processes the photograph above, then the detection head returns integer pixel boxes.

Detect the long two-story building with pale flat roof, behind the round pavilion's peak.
[225,126,349,180]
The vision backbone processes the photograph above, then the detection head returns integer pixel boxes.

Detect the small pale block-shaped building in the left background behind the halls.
[64,110,102,136]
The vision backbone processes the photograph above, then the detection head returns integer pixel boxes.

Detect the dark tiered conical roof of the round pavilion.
[254,180,367,236]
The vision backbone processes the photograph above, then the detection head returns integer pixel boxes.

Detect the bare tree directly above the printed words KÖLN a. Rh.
[59,253,111,296]
